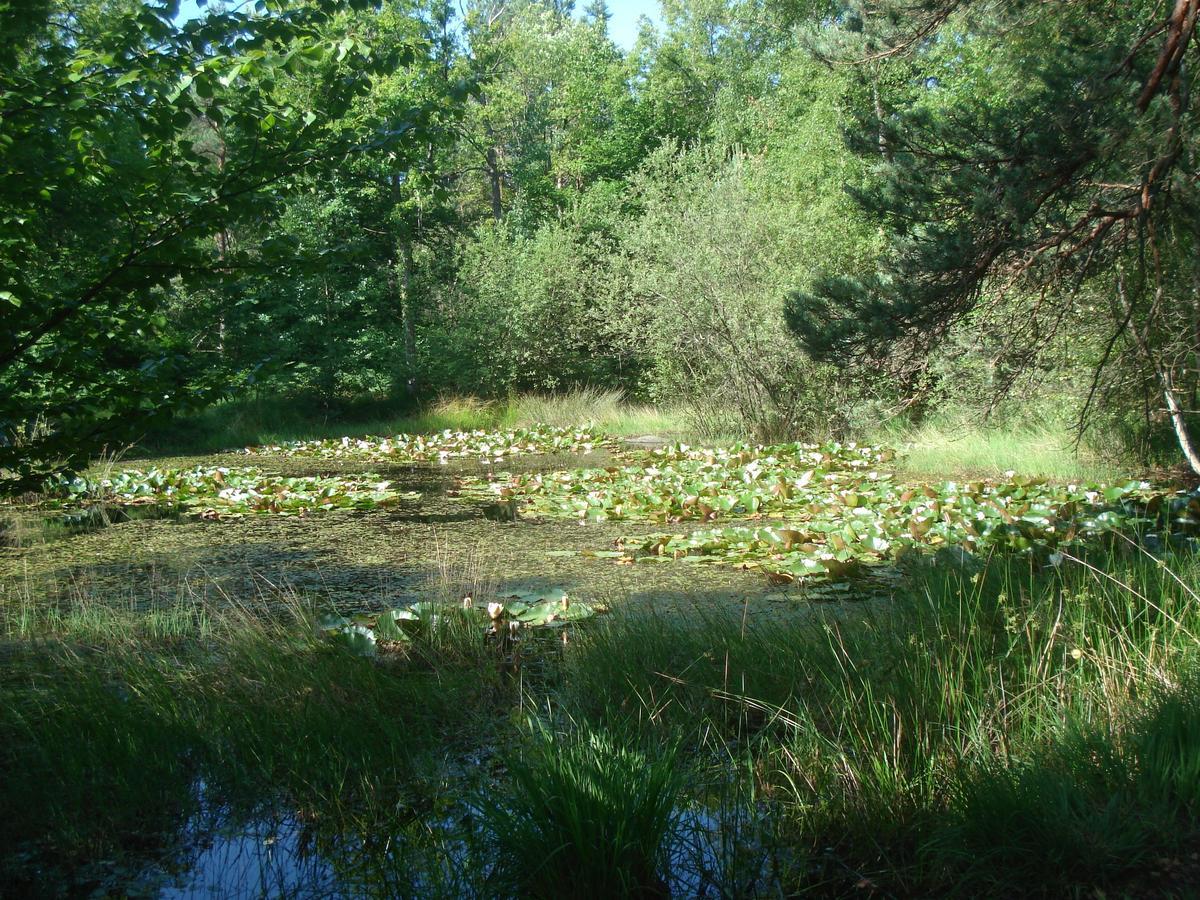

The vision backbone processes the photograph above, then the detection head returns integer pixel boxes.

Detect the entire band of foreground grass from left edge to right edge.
[0,550,1200,896]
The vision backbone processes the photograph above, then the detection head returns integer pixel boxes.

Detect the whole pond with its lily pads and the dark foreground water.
[0,442,1200,896]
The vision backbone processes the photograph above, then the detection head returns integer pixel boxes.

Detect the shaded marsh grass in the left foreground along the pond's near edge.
[0,573,497,890]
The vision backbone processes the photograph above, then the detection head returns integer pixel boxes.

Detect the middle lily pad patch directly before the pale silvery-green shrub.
[460,443,894,523]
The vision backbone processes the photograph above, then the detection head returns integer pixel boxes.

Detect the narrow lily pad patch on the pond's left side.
[42,467,420,518]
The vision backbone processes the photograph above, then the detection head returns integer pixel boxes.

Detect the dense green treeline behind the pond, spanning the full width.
[0,0,1200,484]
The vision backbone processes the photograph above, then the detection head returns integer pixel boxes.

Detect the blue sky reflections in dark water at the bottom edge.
[124,784,773,900]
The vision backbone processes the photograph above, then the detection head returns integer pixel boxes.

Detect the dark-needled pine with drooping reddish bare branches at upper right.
[787,1,1200,468]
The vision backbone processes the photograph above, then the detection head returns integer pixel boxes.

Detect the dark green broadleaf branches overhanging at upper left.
[0,2,417,487]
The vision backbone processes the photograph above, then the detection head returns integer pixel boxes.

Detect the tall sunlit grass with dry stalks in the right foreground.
[560,549,1200,895]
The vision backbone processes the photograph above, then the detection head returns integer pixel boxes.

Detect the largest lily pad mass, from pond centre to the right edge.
[461,444,1200,580]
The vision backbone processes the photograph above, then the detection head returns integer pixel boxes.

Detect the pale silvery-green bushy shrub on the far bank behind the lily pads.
[610,137,865,440]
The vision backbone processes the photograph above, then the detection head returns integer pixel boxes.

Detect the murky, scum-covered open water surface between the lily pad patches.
[0,441,854,613]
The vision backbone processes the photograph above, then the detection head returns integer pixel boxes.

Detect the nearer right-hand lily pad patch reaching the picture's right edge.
[617,478,1200,580]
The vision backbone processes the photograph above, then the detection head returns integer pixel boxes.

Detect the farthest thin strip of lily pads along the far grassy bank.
[246,425,612,463]
